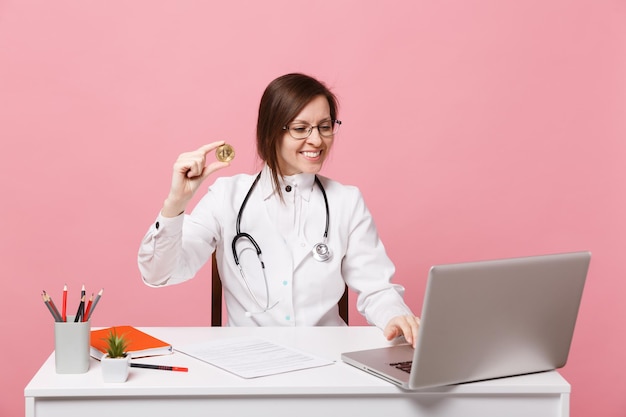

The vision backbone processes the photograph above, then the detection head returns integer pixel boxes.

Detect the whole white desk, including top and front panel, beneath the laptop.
[24,327,570,417]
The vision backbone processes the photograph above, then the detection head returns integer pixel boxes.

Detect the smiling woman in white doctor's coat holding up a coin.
[138,74,419,346]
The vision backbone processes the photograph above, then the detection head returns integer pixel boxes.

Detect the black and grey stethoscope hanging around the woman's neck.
[232,173,332,317]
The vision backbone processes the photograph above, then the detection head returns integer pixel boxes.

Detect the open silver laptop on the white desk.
[341,252,591,390]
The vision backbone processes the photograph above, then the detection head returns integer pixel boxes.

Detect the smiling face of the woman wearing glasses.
[278,96,333,175]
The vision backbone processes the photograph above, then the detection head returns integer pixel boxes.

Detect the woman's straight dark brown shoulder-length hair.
[256,74,339,196]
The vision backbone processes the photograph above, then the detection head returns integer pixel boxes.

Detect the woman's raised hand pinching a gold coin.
[161,140,230,217]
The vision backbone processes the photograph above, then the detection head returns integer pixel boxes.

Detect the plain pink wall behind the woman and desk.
[0,0,626,417]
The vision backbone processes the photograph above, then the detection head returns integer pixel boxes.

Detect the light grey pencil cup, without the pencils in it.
[54,316,91,374]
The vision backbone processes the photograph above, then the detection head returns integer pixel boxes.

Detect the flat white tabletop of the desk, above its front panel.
[24,327,570,416]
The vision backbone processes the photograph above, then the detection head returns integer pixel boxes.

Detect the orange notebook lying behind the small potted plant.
[90,326,173,360]
